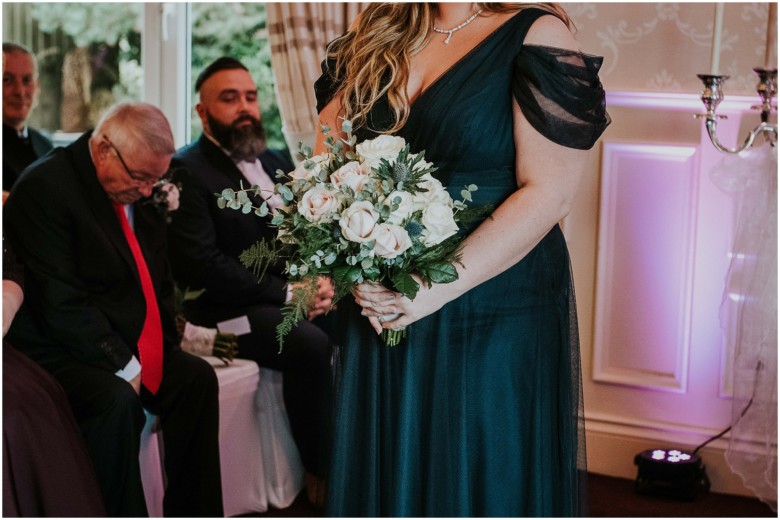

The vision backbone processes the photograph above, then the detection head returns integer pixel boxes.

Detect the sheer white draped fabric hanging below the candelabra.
[712,145,777,511]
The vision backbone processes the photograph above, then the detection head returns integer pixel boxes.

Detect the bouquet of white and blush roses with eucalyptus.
[217,121,489,346]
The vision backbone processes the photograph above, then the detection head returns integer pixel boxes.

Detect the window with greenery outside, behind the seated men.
[3,2,286,153]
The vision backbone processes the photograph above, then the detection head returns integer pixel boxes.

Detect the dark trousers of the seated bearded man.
[184,302,333,475]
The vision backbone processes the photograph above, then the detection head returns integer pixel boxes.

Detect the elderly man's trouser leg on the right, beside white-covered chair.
[142,351,224,517]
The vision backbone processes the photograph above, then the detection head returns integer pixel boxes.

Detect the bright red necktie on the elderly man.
[114,204,162,394]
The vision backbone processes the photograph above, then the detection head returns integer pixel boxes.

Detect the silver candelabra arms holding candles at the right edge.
[696,67,777,153]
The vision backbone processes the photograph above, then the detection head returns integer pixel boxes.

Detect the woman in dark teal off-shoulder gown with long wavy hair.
[315,4,609,517]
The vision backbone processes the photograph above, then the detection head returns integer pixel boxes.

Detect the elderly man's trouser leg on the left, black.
[47,361,148,517]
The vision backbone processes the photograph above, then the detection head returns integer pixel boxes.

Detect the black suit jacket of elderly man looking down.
[3,132,176,373]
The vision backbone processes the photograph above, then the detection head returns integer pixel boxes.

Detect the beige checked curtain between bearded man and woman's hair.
[266,2,366,158]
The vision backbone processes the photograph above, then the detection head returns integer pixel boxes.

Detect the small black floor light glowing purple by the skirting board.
[634,448,710,500]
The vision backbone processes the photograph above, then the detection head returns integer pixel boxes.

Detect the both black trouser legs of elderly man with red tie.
[45,349,223,517]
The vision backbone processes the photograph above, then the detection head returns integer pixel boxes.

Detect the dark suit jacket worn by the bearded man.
[168,135,293,308]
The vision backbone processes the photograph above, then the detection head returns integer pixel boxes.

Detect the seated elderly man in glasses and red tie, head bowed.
[4,103,223,517]
